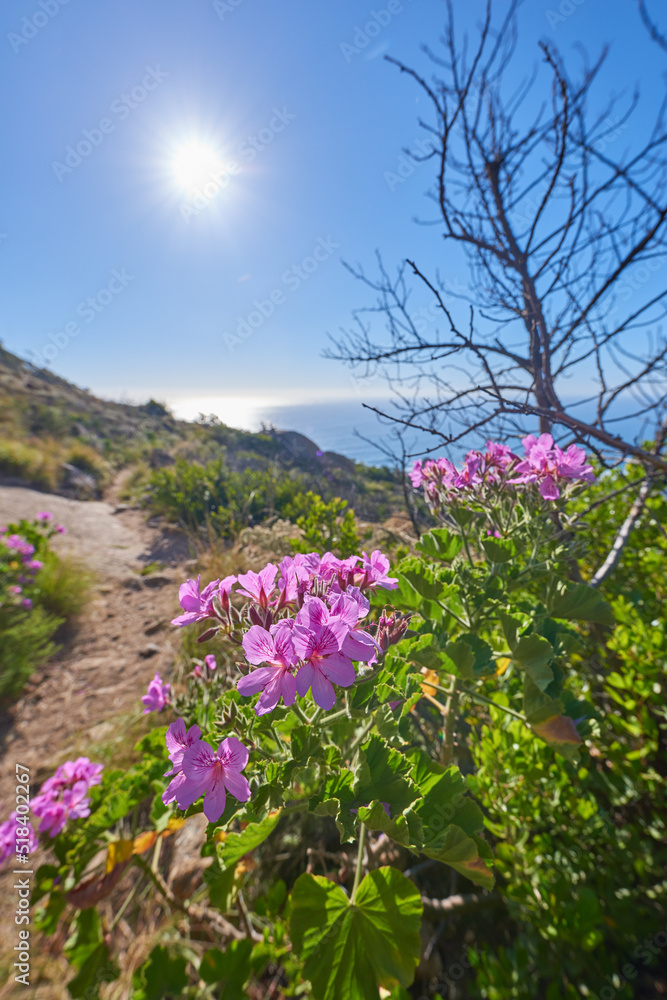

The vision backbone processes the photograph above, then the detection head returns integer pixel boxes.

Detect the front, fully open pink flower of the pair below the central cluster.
[176,736,250,823]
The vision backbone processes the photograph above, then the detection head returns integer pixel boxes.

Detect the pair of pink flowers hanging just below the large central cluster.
[162,719,250,823]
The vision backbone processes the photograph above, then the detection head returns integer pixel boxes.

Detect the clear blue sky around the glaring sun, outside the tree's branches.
[0,0,664,423]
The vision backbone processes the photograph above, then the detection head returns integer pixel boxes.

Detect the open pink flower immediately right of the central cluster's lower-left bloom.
[292,618,355,709]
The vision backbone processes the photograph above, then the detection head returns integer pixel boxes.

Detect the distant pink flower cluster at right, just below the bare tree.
[410,434,595,513]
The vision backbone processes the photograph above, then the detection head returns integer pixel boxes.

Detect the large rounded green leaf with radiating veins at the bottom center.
[290,868,422,1000]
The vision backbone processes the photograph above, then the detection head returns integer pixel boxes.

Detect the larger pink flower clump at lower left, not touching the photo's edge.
[31,757,103,837]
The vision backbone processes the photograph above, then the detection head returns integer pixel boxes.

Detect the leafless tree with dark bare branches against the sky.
[328,0,667,481]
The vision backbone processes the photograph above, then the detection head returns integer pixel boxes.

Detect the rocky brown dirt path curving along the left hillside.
[0,487,189,819]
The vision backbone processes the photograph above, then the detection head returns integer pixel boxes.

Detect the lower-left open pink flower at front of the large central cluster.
[236,621,297,715]
